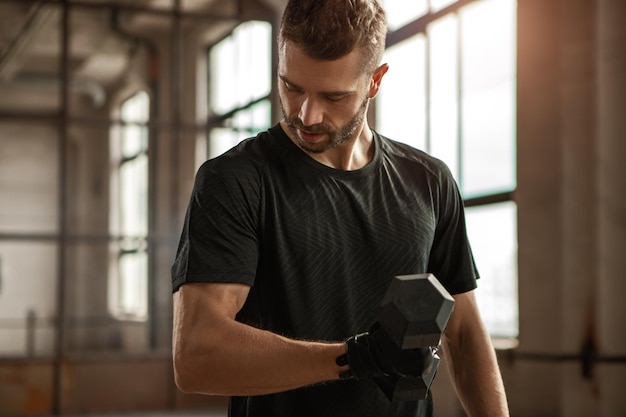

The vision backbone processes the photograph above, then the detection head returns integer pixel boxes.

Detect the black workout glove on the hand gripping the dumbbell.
[337,325,436,379]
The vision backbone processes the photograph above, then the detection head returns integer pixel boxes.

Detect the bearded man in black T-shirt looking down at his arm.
[172,0,508,417]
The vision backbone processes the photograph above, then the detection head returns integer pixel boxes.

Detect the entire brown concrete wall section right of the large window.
[516,0,626,417]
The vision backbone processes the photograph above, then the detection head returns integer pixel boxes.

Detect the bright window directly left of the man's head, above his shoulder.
[209,21,272,157]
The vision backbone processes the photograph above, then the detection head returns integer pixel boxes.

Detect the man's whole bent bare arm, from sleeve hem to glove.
[172,284,347,395]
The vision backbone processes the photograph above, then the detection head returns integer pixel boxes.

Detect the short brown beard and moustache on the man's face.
[280,98,368,153]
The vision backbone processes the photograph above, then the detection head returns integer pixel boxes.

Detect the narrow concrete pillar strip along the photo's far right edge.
[597,0,626,416]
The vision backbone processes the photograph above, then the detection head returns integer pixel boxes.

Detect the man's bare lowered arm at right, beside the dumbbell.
[442,291,509,417]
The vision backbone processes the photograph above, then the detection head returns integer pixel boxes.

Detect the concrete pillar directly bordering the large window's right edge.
[504,0,563,416]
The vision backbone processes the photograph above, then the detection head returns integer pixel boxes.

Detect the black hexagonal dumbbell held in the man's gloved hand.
[374,274,454,402]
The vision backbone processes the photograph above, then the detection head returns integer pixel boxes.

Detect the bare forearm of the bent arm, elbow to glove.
[175,323,345,396]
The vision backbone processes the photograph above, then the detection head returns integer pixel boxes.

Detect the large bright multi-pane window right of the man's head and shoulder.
[376,0,518,338]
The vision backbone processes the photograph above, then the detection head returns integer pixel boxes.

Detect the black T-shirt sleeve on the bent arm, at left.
[171,160,260,291]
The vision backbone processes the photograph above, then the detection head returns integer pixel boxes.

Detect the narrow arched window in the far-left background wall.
[108,92,149,320]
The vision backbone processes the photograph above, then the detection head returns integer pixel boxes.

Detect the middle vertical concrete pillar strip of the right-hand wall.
[559,0,598,417]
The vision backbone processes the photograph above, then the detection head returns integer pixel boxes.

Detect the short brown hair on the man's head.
[278,0,387,73]
